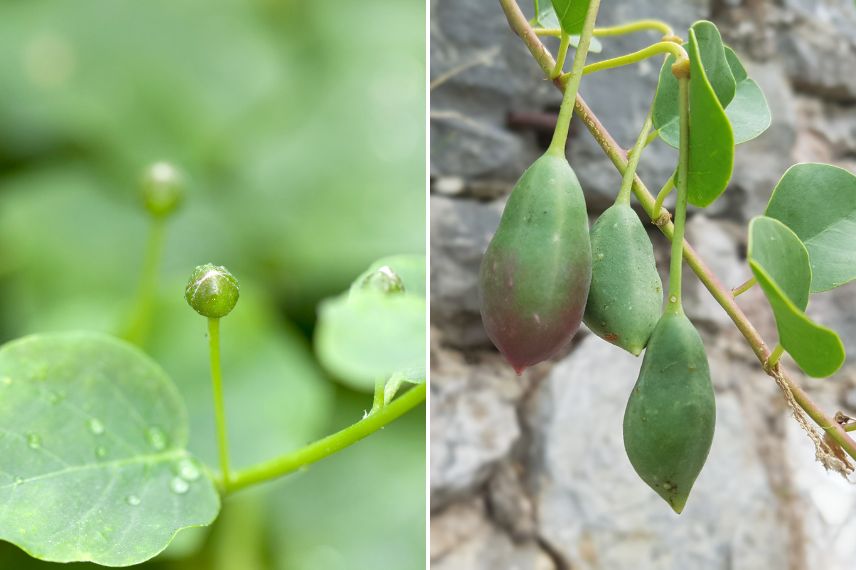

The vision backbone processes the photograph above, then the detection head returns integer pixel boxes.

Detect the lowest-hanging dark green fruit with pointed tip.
[624,311,716,514]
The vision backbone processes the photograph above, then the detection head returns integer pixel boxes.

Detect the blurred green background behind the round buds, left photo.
[0,0,426,570]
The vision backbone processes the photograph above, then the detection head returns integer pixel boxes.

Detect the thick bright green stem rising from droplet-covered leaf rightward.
[228,382,426,492]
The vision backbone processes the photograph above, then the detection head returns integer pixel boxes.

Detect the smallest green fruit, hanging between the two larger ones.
[583,204,663,356]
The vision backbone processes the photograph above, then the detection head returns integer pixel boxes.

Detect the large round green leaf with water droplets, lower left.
[0,333,220,566]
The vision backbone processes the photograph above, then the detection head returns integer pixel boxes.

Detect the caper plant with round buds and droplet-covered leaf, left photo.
[0,162,426,566]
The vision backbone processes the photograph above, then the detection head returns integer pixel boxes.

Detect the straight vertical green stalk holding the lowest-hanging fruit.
[666,77,690,314]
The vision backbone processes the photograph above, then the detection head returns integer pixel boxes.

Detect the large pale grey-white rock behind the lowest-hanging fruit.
[528,337,788,570]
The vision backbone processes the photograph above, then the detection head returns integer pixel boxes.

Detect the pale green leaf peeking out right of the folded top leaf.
[725,46,772,144]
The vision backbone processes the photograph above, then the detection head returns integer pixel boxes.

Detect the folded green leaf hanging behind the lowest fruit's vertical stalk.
[652,22,734,207]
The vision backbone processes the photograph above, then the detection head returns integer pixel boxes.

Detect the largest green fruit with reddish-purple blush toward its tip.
[479,152,591,374]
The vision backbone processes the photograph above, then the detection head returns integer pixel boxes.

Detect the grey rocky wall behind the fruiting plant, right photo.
[431,0,856,570]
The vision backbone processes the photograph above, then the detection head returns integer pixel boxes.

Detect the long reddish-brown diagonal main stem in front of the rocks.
[499,0,856,459]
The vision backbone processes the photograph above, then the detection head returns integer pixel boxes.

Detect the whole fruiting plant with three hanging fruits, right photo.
[480,0,856,514]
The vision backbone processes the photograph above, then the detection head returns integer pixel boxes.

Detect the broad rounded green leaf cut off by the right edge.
[765,163,856,293]
